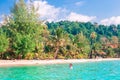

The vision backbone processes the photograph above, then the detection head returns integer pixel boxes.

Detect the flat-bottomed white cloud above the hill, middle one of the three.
[67,12,96,22]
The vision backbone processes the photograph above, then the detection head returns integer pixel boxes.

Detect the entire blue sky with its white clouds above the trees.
[0,0,120,25]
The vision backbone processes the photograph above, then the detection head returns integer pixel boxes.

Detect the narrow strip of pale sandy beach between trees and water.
[0,58,120,67]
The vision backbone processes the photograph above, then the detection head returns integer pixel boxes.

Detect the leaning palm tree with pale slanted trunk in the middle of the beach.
[47,27,67,59]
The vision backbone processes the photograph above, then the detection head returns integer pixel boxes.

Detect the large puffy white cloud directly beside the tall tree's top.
[33,0,65,21]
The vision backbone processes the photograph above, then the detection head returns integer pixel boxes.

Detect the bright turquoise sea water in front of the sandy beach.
[0,60,120,80]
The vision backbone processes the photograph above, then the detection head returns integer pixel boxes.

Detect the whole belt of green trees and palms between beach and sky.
[0,0,120,59]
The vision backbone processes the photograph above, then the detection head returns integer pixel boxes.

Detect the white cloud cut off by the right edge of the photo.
[100,16,120,25]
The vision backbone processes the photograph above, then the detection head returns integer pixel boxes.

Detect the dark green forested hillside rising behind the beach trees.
[46,21,120,40]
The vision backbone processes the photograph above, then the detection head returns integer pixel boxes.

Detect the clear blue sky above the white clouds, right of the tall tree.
[47,0,120,20]
